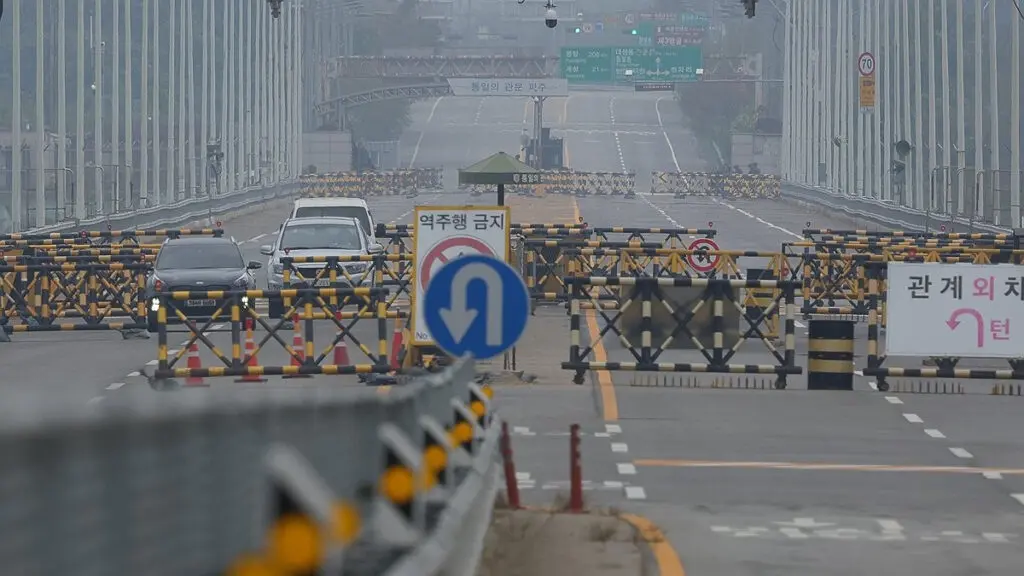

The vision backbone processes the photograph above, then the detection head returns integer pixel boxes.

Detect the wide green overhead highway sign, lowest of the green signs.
[561,46,703,83]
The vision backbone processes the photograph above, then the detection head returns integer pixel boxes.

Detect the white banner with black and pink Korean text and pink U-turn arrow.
[886,262,1024,358]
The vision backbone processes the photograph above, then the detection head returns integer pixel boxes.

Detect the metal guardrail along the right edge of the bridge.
[782,182,1013,234]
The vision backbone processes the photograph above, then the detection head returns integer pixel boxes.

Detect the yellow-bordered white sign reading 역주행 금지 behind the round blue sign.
[412,206,512,345]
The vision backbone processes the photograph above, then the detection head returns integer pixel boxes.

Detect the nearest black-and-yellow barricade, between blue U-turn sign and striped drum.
[562,277,803,388]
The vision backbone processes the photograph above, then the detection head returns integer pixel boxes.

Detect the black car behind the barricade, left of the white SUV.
[145,237,262,332]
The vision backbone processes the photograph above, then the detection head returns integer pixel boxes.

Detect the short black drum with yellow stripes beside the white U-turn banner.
[807,319,855,390]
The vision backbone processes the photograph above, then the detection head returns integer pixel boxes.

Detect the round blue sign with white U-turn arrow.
[423,254,529,360]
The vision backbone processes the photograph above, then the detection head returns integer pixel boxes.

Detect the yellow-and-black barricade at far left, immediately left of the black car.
[0,262,152,338]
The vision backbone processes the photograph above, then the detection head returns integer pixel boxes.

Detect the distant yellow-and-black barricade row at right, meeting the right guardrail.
[650,171,782,200]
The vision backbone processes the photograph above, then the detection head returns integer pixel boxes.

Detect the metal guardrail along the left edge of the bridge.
[23,180,298,234]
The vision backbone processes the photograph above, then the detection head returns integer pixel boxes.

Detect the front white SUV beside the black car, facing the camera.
[259,217,384,318]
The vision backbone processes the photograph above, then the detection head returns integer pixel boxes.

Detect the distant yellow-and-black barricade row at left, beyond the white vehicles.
[299,168,444,198]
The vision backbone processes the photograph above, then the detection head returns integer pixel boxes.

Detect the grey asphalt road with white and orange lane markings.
[8,87,1024,576]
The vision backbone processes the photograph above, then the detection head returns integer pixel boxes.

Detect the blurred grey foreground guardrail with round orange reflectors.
[0,360,501,576]
